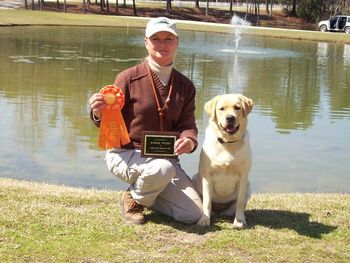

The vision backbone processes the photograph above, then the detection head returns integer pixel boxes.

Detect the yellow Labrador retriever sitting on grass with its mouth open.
[194,94,253,228]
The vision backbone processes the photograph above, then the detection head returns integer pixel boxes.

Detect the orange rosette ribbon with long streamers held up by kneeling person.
[98,85,130,149]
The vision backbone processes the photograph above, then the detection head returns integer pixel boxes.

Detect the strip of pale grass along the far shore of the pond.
[0,9,350,43]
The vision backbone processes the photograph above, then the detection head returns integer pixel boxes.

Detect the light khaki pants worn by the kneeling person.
[106,149,202,224]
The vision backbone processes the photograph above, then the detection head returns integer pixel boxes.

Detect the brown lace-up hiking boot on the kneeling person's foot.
[120,190,145,225]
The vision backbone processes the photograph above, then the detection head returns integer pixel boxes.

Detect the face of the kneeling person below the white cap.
[145,31,179,66]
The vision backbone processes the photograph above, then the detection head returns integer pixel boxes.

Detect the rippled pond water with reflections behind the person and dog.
[0,27,350,192]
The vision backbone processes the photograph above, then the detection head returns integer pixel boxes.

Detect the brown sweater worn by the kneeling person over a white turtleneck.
[94,61,198,150]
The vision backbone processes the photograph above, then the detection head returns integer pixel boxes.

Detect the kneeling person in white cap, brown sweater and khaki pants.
[90,17,202,224]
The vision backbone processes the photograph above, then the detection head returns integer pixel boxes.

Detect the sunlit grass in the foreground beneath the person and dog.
[0,178,350,262]
